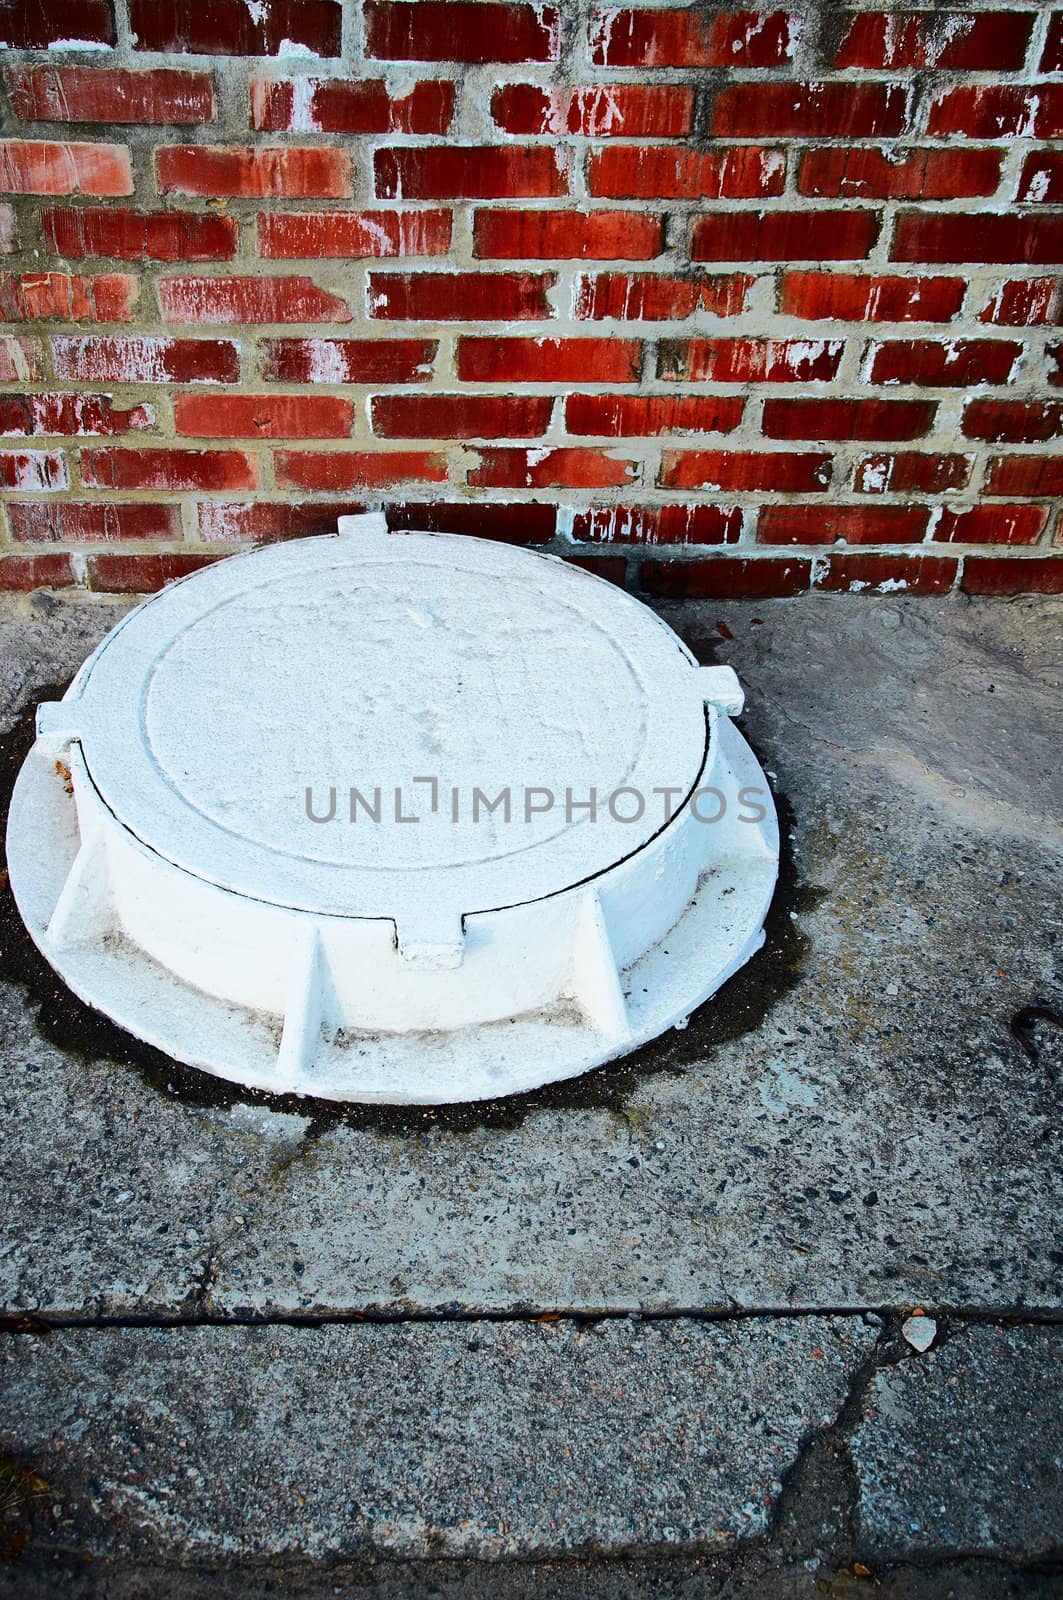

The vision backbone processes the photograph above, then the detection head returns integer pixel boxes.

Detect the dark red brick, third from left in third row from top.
[373,144,568,200]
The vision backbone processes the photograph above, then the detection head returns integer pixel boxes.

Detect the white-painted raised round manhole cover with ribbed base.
[8,517,778,1102]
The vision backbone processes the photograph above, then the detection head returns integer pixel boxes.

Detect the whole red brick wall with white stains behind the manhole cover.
[0,0,1063,597]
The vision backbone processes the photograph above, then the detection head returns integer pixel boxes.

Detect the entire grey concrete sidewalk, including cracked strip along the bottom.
[0,597,1063,1600]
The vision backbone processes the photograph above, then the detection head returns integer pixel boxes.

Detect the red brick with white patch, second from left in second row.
[251,78,455,134]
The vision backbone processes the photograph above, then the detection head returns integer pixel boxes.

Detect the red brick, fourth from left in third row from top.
[588,144,786,200]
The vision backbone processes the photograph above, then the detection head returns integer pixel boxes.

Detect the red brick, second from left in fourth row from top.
[258,211,450,261]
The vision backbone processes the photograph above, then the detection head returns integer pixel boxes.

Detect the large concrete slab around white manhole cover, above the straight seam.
[0,597,1063,1322]
